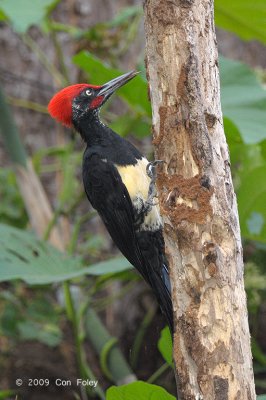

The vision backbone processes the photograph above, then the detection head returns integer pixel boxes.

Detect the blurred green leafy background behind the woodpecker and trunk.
[0,0,266,400]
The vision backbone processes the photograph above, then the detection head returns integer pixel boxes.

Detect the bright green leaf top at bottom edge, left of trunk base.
[106,381,175,400]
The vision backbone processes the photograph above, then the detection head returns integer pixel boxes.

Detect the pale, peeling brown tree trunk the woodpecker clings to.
[144,0,255,400]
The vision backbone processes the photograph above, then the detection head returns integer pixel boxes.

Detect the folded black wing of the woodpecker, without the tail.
[83,154,148,280]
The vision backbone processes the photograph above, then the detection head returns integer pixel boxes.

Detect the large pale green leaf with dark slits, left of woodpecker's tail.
[0,224,132,284]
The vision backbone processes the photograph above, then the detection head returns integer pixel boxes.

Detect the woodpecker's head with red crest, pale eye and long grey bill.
[48,71,138,127]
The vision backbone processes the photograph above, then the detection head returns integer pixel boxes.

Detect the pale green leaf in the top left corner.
[0,0,57,33]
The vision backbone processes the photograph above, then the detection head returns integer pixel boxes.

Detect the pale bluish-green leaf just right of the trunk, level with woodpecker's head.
[220,57,266,143]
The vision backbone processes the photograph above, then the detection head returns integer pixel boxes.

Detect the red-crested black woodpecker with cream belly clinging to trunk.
[48,71,173,332]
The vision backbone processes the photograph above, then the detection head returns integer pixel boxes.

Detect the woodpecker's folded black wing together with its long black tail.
[83,154,173,331]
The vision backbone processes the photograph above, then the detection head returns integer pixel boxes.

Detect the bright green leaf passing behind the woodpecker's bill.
[73,51,151,115]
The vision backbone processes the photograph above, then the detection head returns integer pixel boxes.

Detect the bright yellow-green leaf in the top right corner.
[214,0,266,43]
